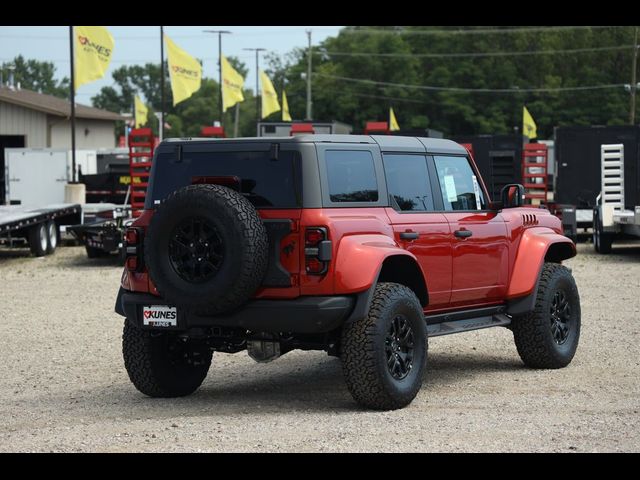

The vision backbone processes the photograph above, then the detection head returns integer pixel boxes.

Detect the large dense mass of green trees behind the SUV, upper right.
[270,26,633,138]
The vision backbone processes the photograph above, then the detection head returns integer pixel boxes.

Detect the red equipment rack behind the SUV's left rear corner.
[129,128,156,217]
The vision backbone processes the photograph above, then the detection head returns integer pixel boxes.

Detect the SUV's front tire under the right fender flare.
[511,263,580,369]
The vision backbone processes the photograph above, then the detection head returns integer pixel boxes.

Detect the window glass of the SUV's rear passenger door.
[383,154,433,212]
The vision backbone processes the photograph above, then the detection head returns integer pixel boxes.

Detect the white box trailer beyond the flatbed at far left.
[2,148,97,205]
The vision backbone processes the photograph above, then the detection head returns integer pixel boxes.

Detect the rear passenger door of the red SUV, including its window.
[383,153,451,310]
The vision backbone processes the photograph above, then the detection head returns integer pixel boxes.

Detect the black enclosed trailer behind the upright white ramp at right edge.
[550,125,640,241]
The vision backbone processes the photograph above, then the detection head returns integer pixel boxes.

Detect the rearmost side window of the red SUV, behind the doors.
[325,150,378,202]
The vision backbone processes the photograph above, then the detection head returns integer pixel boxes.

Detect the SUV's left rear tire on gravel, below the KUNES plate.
[122,319,212,398]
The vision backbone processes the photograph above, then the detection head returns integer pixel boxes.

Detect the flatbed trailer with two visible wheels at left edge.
[0,204,82,257]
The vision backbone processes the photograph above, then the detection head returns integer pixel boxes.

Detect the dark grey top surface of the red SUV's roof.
[162,135,467,154]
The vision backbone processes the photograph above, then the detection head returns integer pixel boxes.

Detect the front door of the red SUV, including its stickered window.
[433,155,509,307]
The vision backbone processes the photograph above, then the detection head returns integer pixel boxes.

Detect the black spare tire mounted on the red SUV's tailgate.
[144,185,269,315]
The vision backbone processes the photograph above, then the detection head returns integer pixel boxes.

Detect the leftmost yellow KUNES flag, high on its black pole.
[73,27,115,90]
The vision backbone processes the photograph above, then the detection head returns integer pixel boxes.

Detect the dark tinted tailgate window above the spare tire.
[146,145,302,208]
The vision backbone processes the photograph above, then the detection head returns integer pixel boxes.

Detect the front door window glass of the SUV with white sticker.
[434,155,487,211]
